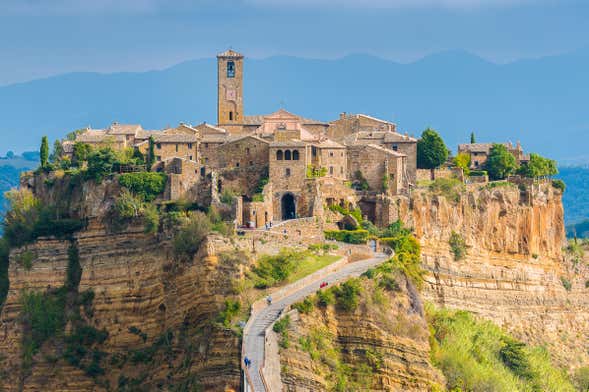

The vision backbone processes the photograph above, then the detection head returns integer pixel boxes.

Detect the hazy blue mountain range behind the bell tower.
[0,49,589,163]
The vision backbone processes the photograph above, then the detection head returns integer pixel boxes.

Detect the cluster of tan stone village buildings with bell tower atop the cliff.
[62,50,529,227]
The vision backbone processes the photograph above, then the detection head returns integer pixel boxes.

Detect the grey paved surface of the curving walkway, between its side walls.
[243,254,390,392]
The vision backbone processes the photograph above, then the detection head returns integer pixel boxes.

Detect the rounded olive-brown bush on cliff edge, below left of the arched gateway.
[172,211,211,259]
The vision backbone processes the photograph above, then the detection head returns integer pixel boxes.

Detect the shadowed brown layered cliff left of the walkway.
[0,224,240,391]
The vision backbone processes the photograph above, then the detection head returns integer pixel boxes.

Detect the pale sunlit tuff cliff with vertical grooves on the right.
[405,184,589,368]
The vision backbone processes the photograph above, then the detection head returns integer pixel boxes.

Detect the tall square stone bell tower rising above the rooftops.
[217,49,244,130]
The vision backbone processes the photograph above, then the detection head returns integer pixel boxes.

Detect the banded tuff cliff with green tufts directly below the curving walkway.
[280,274,444,391]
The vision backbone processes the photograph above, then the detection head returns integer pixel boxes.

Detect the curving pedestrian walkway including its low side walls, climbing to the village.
[241,254,390,392]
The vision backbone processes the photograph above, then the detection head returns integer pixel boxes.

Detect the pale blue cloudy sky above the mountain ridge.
[0,0,589,85]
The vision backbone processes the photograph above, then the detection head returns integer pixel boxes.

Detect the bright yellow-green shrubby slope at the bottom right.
[426,305,575,392]
